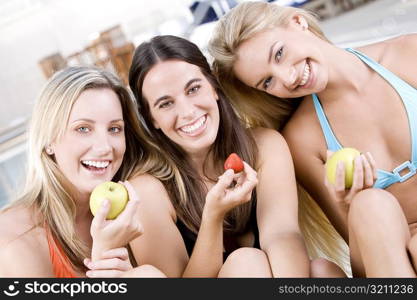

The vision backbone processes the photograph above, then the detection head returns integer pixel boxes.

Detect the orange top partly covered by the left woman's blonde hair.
[45,225,77,278]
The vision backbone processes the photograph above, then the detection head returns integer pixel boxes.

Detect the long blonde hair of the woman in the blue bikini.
[208,2,349,271]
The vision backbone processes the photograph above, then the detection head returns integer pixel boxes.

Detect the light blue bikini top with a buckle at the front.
[312,48,417,189]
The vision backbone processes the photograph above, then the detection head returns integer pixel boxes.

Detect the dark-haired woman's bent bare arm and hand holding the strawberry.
[131,170,257,277]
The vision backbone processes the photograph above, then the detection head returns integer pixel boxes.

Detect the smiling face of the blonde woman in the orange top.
[51,88,126,194]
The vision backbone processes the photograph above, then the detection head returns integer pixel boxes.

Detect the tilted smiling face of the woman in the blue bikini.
[233,16,328,98]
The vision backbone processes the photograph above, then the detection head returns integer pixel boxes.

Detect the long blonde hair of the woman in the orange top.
[5,67,147,270]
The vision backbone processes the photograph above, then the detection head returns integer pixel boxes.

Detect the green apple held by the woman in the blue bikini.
[326,148,361,189]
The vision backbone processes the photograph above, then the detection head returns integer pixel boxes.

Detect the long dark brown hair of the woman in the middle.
[129,35,257,233]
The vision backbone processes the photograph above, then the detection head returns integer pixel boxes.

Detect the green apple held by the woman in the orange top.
[90,181,129,220]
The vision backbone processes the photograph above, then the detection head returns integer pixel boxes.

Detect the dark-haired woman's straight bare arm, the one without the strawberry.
[250,129,310,277]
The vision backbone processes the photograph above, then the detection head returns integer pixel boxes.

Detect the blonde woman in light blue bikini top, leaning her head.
[210,2,417,277]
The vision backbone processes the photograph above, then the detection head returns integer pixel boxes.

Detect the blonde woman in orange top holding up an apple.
[0,67,163,277]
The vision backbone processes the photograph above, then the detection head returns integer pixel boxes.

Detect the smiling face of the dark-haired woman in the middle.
[142,60,219,154]
